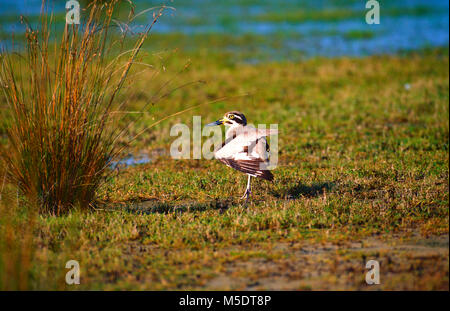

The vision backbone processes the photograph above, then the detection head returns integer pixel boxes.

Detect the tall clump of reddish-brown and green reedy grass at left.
[0,0,162,215]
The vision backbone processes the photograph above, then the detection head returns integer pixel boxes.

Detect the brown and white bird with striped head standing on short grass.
[206,111,278,201]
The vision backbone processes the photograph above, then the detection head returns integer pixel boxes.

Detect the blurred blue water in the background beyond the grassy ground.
[0,0,449,59]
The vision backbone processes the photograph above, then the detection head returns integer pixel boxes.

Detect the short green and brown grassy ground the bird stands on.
[1,45,449,290]
